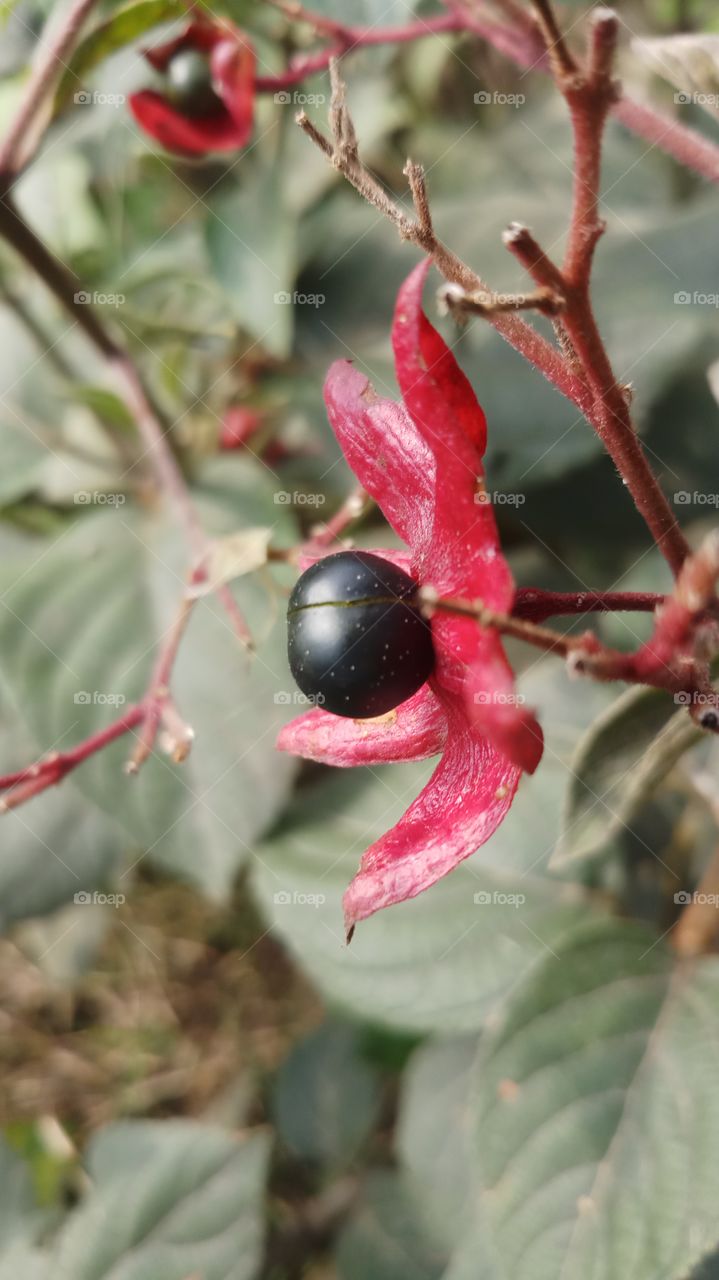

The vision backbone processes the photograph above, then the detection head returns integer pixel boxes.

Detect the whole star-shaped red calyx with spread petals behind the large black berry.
[278,262,542,932]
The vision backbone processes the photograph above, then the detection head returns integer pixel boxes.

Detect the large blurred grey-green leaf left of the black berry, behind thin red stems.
[0,457,294,896]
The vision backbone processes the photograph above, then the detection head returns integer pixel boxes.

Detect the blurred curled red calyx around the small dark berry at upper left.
[129,18,255,155]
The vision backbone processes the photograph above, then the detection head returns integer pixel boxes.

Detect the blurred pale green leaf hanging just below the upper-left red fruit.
[206,166,296,357]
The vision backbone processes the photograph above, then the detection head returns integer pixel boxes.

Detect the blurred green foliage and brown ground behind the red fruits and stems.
[0,0,719,1280]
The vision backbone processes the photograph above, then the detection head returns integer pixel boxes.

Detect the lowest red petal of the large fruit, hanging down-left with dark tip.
[344,705,521,931]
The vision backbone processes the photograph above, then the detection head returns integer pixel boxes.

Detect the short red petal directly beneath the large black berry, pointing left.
[278,685,446,768]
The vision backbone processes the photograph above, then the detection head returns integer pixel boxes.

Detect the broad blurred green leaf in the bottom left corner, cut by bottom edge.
[52,1120,269,1280]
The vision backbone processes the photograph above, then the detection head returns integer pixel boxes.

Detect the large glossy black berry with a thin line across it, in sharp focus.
[287,552,435,719]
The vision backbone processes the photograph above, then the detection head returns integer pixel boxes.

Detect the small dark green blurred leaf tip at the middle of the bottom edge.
[335,1171,445,1280]
